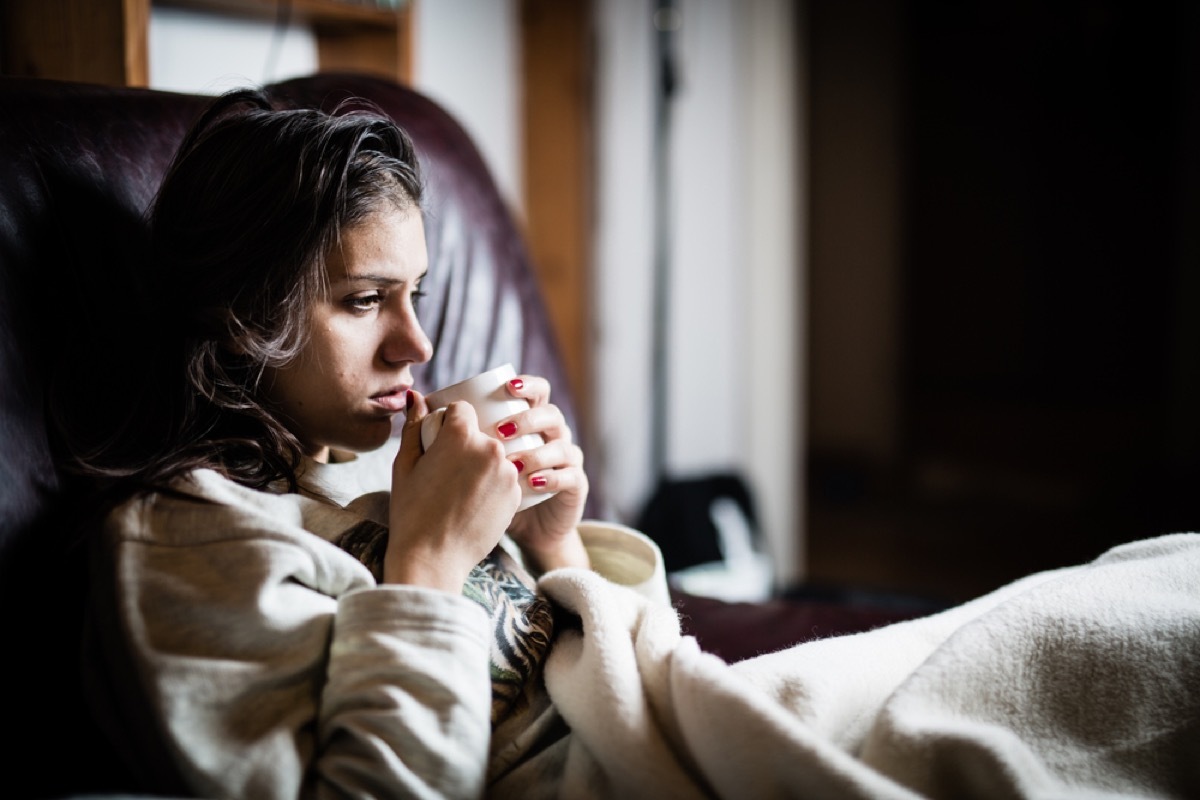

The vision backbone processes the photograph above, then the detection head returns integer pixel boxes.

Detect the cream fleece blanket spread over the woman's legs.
[542,534,1200,800]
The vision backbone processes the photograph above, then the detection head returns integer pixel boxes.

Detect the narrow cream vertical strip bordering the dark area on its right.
[738,0,809,585]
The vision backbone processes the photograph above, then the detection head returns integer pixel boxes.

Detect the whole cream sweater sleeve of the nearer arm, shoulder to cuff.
[87,482,491,798]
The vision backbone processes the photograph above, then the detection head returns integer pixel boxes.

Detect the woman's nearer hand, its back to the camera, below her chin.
[384,391,521,594]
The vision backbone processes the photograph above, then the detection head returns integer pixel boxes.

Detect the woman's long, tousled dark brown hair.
[64,90,422,491]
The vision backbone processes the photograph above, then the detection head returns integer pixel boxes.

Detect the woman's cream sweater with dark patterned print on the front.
[92,443,667,798]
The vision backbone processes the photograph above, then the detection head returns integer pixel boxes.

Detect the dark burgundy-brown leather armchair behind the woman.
[0,76,902,796]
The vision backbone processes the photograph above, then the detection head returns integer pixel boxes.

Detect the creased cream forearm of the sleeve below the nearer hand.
[316,588,492,798]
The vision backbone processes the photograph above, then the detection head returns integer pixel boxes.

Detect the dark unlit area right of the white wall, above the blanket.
[804,0,1200,600]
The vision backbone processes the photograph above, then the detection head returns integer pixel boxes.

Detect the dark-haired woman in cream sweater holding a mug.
[84,90,661,798]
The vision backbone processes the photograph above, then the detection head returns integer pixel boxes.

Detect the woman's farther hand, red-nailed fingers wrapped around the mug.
[497,375,589,572]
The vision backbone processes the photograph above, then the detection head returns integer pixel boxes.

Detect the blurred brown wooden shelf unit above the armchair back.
[0,0,413,86]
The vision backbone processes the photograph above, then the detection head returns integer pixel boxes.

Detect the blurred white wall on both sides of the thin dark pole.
[594,0,804,581]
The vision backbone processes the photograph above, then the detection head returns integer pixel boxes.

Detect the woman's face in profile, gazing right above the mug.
[265,206,433,461]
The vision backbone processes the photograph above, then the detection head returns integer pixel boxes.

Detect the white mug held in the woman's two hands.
[421,363,554,511]
